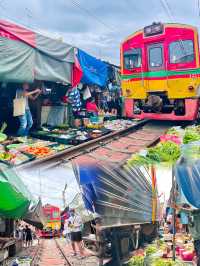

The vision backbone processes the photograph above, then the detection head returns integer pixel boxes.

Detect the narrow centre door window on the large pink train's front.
[149,46,163,68]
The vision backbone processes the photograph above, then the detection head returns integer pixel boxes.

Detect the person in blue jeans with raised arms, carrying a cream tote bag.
[16,83,41,136]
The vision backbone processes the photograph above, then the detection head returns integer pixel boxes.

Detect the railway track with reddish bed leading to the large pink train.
[16,121,174,172]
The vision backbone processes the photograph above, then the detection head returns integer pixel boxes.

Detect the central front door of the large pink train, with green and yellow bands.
[147,43,167,93]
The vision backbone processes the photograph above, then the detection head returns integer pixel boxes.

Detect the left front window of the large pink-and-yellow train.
[124,48,142,69]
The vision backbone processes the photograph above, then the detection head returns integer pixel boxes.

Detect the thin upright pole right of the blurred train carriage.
[172,166,176,261]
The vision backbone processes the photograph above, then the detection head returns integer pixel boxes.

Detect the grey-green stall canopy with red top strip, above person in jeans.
[0,20,74,84]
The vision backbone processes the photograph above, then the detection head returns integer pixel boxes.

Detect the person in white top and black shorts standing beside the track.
[68,209,84,258]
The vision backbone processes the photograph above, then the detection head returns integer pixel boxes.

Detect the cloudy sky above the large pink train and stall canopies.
[0,0,200,64]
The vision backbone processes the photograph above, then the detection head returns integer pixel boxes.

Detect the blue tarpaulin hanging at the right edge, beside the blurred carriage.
[175,160,200,209]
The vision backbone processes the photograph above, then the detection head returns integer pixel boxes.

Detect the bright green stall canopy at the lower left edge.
[0,165,33,219]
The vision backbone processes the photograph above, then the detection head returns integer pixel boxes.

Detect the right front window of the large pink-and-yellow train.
[169,40,195,64]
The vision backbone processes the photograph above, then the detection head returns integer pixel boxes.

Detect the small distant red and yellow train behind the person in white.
[40,204,61,238]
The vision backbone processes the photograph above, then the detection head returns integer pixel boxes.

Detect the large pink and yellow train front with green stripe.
[120,22,200,121]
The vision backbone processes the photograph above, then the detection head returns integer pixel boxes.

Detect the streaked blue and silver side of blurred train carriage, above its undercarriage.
[72,163,157,226]
